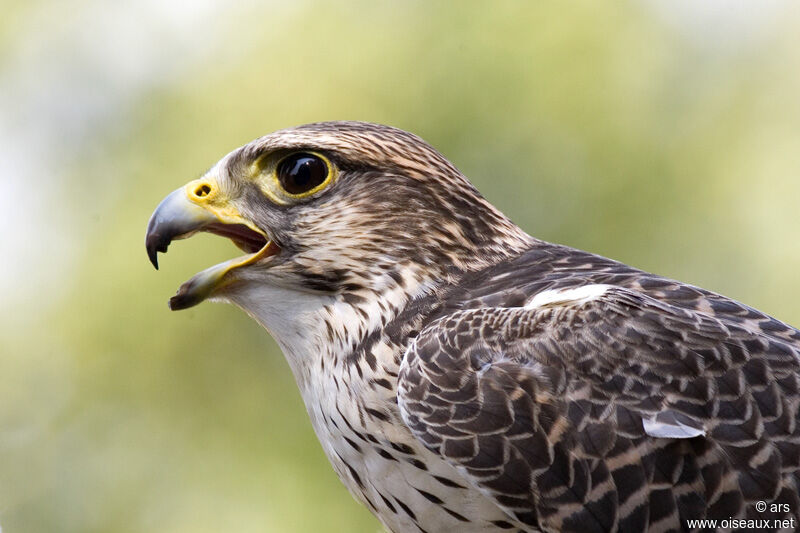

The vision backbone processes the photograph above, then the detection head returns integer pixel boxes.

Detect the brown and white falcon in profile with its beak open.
[146,122,800,533]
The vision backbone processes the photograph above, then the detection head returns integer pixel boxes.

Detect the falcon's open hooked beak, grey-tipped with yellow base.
[145,179,280,311]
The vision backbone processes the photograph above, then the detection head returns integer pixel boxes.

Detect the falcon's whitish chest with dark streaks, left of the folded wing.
[296,328,514,533]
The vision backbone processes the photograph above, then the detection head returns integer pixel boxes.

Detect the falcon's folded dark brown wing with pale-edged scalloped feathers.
[398,286,800,532]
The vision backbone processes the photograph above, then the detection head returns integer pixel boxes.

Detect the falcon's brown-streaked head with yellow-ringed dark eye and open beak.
[146,122,530,329]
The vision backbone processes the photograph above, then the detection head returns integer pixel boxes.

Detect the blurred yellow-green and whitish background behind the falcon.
[0,0,800,533]
